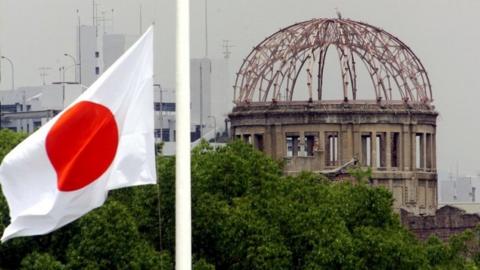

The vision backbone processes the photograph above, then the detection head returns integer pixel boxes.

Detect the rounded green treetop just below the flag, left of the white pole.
[67,200,160,269]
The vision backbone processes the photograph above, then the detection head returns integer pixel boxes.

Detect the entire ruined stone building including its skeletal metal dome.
[229,18,438,214]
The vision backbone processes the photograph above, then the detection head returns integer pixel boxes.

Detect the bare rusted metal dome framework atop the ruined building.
[234,18,433,105]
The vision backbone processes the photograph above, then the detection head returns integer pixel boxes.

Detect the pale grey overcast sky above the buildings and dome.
[0,0,480,176]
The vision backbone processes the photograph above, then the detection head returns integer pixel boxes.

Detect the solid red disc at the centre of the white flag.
[45,101,118,191]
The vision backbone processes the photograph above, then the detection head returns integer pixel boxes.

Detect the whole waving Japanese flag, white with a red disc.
[0,27,156,242]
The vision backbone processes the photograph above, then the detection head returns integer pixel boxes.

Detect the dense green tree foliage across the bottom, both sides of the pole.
[0,130,480,269]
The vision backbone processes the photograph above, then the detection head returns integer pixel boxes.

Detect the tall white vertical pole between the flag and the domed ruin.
[175,0,192,270]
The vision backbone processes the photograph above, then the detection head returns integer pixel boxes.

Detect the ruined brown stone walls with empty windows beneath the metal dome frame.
[230,102,437,214]
